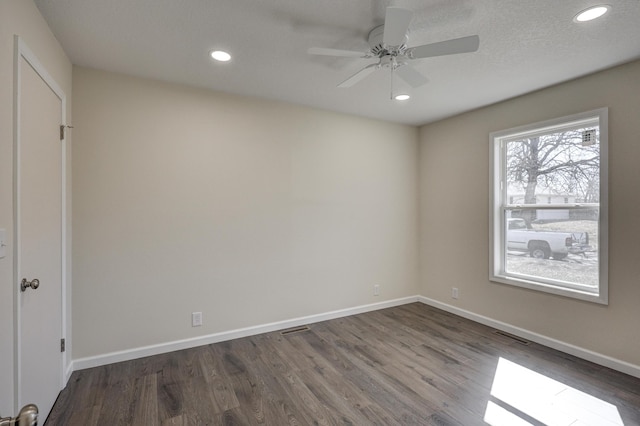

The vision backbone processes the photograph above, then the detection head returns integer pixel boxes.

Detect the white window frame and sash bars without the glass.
[489,108,609,305]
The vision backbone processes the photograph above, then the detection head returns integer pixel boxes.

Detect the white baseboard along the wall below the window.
[418,296,640,378]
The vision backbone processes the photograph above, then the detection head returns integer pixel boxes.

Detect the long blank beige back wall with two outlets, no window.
[73,68,418,359]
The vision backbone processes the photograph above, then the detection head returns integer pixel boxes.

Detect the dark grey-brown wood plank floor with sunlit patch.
[46,303,640,426]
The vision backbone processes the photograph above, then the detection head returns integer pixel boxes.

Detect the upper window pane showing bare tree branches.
[505,126,600,204]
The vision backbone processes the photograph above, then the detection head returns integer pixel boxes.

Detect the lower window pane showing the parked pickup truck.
[504,208,599,289]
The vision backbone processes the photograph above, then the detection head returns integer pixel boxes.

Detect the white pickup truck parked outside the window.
[507,218,591,260]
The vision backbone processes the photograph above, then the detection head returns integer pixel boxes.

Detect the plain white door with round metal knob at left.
[16,38,64,423]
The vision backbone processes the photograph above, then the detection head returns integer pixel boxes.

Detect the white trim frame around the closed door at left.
[13,35,70,412]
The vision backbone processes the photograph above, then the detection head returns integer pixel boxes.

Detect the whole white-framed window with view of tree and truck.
[489,108,608,304]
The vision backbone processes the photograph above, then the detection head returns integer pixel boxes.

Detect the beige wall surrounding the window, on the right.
[419,62,640,366]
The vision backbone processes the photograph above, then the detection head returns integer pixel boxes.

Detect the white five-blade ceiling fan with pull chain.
[308,6,480,97]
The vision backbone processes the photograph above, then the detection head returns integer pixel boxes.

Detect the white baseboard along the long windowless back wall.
[68,296,418,375]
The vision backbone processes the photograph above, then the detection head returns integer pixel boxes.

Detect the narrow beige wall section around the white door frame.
[0,0,72,416]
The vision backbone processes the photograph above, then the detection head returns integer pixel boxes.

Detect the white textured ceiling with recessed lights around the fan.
[35,0,640,125]
